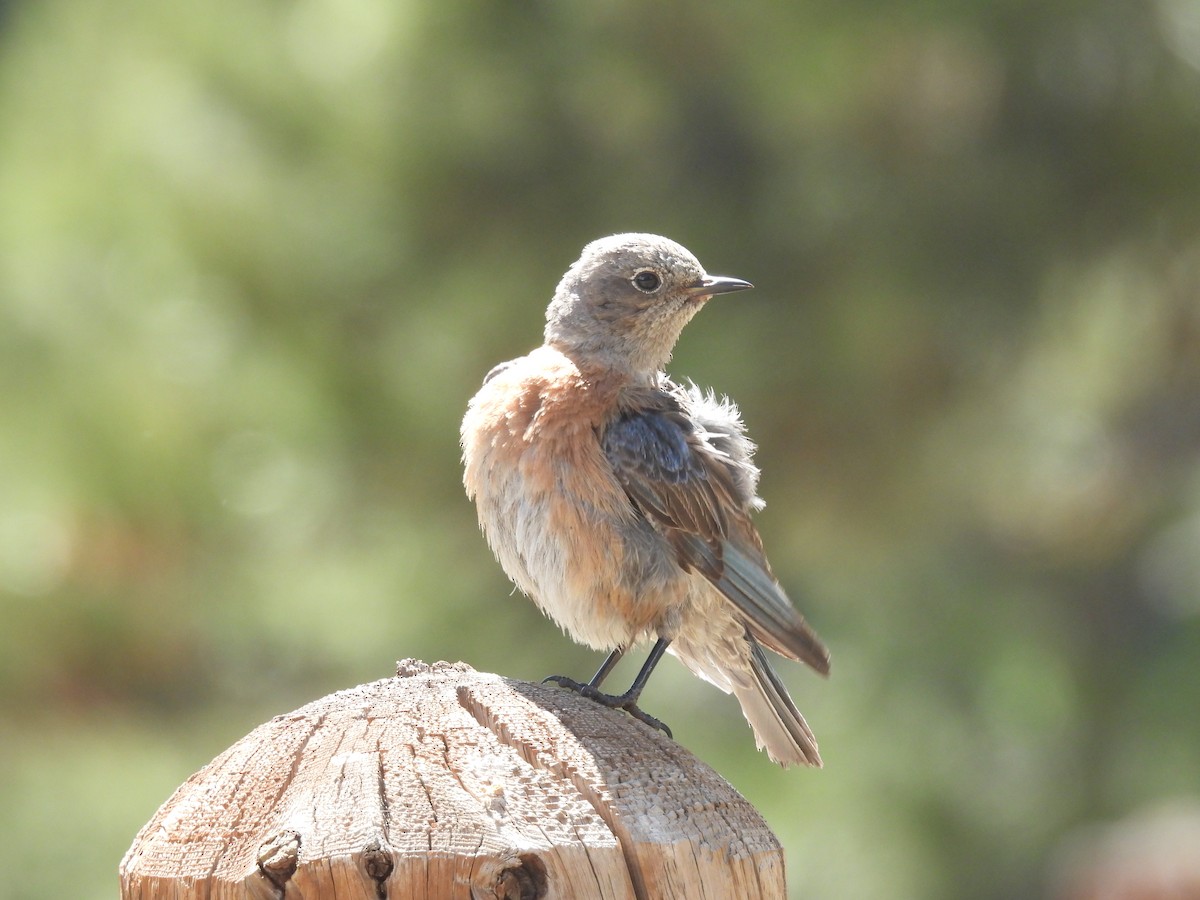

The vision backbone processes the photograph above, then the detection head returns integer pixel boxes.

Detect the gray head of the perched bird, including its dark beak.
[546,234,751,376]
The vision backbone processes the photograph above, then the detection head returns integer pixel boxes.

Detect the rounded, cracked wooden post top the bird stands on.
[120,660,786,900]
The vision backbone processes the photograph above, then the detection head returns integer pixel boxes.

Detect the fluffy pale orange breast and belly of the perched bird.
[462,347,660,647]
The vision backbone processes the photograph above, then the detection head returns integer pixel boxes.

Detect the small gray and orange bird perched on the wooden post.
[461,233,829,768]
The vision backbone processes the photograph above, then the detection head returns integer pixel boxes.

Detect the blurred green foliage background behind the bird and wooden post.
[0,0,1200,900]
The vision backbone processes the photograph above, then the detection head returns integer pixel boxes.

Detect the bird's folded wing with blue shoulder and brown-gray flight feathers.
[601,401,829,673]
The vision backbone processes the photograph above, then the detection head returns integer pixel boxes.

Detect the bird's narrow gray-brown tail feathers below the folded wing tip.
[732,635,821,768]
